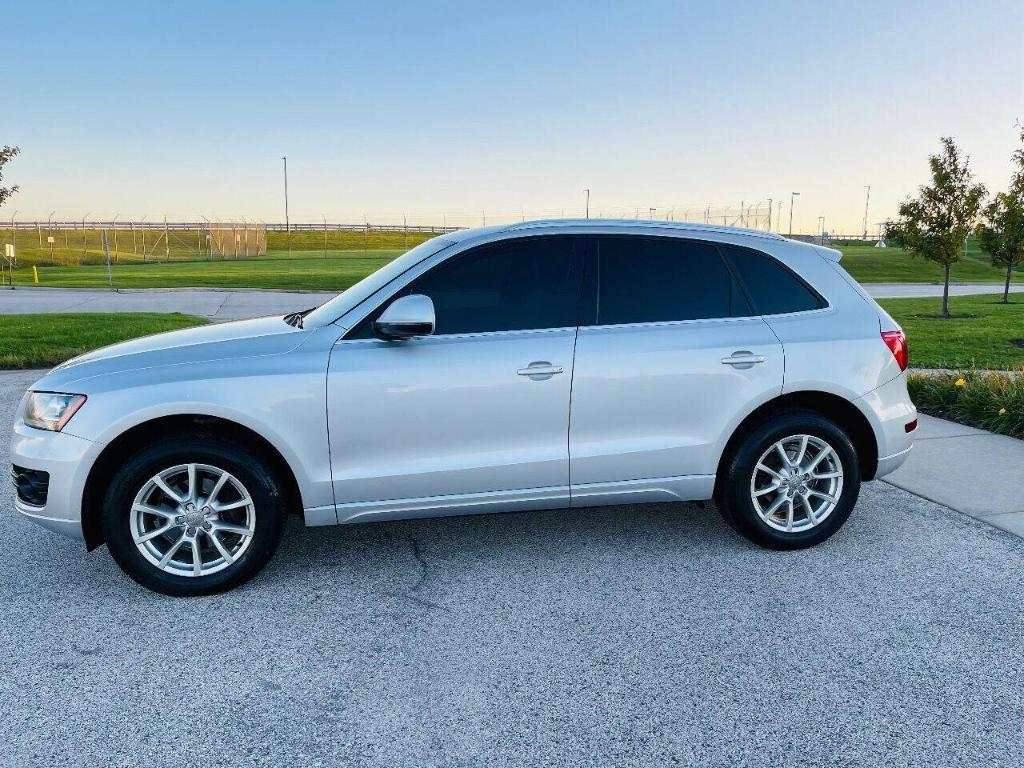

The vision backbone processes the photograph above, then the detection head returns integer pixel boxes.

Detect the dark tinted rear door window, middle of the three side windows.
[597,238,751,326]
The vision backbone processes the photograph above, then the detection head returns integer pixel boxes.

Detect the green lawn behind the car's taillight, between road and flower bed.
[879,296,1024,369]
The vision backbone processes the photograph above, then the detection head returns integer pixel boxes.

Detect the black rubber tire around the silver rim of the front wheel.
[101,432,288,596]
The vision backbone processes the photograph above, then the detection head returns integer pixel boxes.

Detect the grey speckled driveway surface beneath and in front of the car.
[0,373,1024,768]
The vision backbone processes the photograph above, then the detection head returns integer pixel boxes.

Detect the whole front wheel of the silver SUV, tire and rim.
[102,434,286,595]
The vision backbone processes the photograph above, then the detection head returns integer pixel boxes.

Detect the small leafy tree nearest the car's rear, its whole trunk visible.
[887,136,985,317]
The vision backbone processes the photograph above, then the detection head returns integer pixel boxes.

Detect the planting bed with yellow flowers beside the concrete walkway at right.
[907,369,1024,438]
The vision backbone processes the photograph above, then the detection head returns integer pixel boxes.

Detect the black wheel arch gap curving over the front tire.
[82,414,302,551]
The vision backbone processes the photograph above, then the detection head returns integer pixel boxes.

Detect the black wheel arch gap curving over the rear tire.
[716,390,879,493]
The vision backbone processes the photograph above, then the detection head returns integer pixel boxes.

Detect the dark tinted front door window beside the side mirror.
[348,238,584,338]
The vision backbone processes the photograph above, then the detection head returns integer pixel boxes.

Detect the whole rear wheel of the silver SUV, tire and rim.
[718,412,860,549]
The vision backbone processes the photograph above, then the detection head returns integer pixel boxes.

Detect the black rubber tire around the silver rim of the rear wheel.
[716,411,860,550]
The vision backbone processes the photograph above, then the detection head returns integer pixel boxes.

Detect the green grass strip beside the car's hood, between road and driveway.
[0,312,207,369]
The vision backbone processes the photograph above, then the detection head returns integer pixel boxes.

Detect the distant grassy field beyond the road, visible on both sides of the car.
[0,228,1024,291]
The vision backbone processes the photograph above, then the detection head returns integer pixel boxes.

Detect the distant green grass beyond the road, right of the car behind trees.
[839,238,1024,284]
